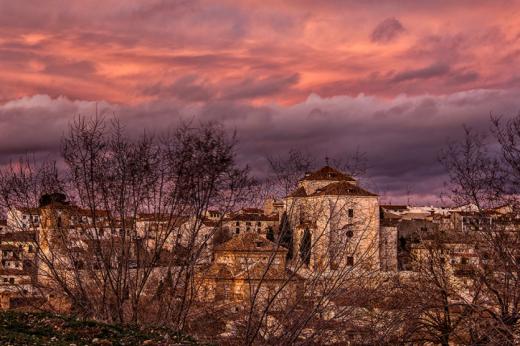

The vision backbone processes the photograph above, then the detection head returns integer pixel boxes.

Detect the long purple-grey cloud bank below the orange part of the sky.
[0,90,520,203]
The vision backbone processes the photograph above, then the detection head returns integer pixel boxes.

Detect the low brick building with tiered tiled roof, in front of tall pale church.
[198,232,302,309]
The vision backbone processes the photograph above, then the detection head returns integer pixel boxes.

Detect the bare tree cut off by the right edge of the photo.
[441,116,520,344]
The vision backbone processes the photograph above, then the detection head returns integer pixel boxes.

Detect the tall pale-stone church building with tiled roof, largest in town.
[284,166,380,271]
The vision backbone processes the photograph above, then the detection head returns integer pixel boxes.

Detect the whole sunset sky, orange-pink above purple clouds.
[0,0,520,204]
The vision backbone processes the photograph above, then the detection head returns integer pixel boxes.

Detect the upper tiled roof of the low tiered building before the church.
[214,232,287,252]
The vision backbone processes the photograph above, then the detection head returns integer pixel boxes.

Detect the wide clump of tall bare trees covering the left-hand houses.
[0,117,249,329]
